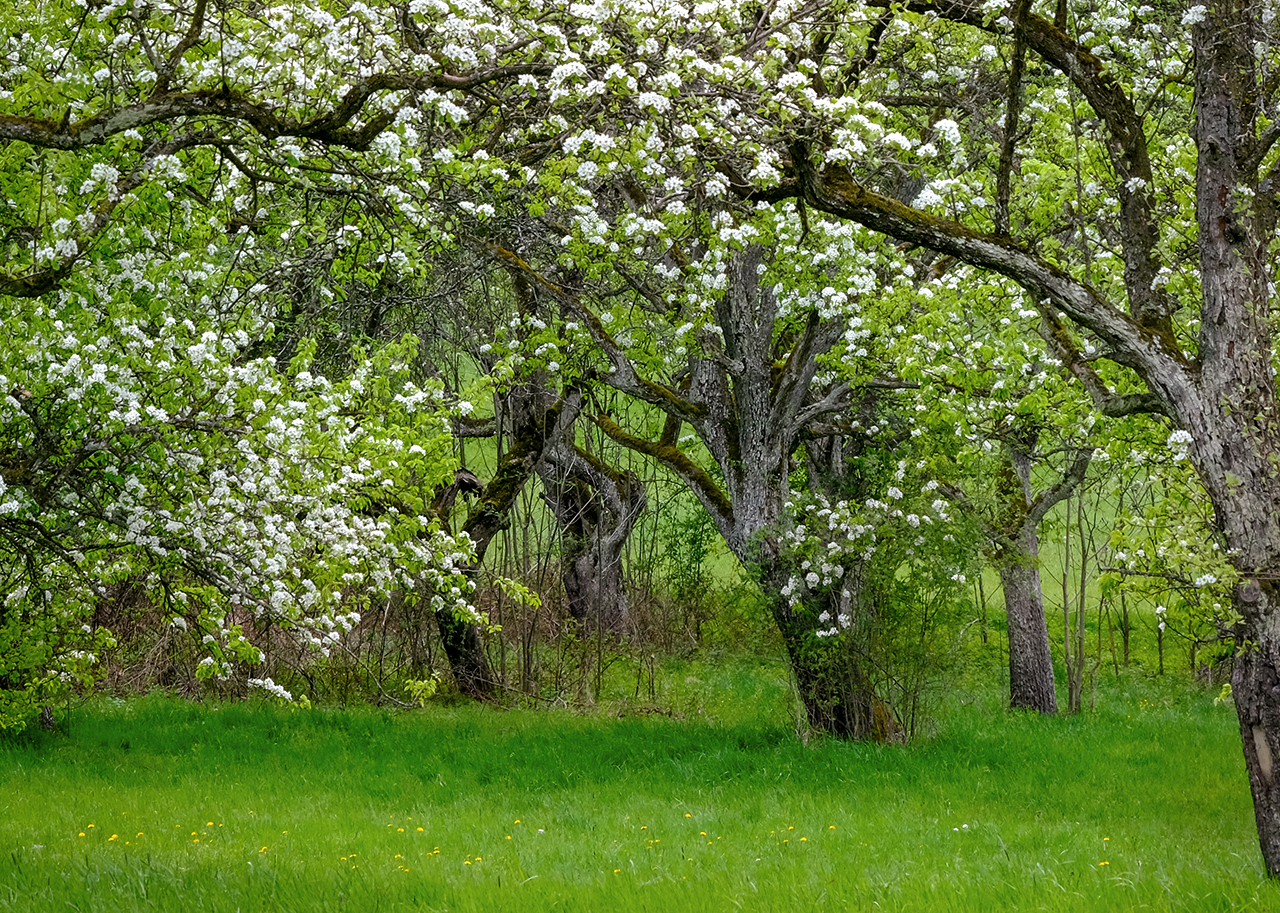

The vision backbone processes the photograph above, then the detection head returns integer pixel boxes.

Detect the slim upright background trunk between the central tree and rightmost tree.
[1000,526,1057,713]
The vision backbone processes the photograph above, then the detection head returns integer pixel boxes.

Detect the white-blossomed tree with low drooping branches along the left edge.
[0,0,570,725]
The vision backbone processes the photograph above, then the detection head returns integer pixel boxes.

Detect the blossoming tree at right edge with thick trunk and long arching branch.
[670,0,1280,875]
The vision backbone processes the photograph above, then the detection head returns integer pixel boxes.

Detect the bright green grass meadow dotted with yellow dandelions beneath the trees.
[0,665,1280,913]
